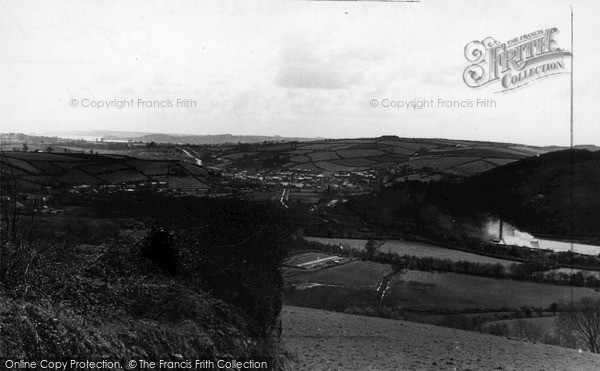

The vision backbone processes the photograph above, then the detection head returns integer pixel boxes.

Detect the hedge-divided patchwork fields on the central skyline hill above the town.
[220,136,550,175]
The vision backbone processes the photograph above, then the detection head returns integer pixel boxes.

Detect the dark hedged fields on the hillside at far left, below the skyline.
[0,152,210,190]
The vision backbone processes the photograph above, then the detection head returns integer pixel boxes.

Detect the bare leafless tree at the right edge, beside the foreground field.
[558,298,600,353]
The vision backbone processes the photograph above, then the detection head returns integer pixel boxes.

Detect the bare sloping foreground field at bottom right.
[282,306,600,371]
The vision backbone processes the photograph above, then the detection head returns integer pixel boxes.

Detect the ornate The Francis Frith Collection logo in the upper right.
[463,28,571,91]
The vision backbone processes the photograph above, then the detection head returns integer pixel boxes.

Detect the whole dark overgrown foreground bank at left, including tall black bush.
[0,197,289,368]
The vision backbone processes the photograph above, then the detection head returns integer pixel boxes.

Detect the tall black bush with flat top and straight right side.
[142,198,291,348]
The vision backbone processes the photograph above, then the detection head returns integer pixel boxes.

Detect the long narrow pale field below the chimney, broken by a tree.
[305,237,514,267]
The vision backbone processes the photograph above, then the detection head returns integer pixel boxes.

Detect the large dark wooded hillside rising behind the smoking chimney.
[322,149,600,245]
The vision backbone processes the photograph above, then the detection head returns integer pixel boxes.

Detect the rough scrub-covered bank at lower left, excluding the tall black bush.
[0,238,272,360]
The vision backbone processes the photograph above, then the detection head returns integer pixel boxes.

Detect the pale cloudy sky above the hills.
[0,0,600,145]
